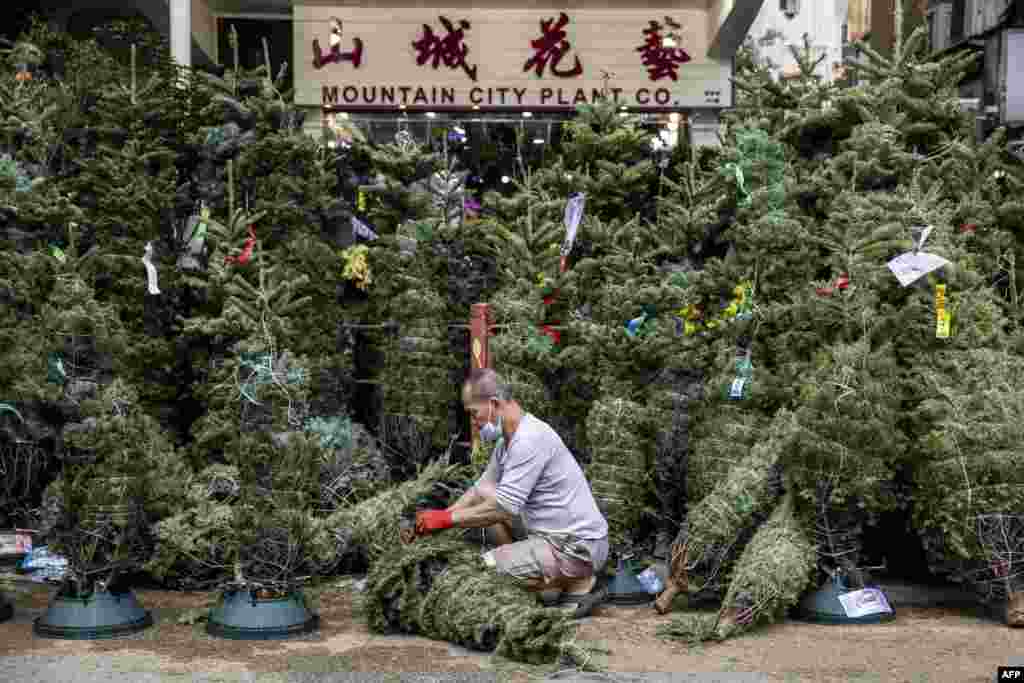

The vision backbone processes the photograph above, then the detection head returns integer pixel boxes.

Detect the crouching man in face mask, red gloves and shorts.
[405,369,608,617]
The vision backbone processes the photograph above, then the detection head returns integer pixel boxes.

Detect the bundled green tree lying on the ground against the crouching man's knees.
[367,536,573,664]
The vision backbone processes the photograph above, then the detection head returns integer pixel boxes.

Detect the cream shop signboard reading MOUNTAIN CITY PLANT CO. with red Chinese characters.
[294,3,733,111]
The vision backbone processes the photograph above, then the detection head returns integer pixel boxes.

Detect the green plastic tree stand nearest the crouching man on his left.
[206,590,319,640]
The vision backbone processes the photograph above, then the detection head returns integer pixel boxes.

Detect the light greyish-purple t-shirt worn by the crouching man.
[476,413,608,546]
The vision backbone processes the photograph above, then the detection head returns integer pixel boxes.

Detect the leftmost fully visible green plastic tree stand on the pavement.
[33,591,153,640]
